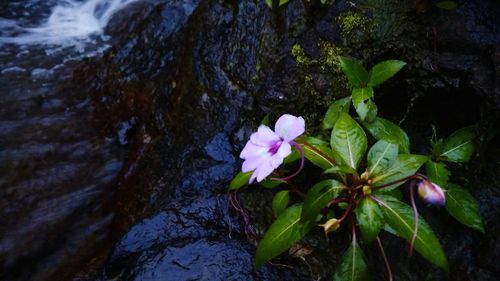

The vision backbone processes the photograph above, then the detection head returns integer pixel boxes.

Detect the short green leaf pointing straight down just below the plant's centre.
[355,197,384,243]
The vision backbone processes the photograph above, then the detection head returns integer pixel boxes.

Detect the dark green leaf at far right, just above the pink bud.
[435,126,476,163]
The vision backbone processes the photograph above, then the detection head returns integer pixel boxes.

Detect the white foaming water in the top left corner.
[0,0,137,47]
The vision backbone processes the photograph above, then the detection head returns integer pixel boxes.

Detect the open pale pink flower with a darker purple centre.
[240,114,305,183]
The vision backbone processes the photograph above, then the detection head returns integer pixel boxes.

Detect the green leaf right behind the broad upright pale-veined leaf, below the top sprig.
[361,117,410,153]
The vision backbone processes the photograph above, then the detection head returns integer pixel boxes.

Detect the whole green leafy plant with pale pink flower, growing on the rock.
[230,57,484,280]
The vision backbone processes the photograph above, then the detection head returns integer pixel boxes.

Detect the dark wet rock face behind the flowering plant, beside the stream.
[71,1,496,280]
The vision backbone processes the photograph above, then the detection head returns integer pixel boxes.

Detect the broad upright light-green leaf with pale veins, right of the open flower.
[330,113,368,169]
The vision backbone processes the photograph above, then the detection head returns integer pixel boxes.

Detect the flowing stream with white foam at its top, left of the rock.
[0,0,140,280]
